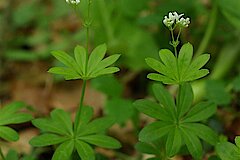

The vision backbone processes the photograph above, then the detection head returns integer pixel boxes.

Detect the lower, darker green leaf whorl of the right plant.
[134,83,218,159]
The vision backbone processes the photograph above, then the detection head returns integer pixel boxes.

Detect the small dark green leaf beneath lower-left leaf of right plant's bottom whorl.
[135,142,159,155]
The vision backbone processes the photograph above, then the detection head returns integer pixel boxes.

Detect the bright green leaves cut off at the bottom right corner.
[216,136,240,160]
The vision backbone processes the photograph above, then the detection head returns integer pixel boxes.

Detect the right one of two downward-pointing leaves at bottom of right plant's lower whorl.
[181,128,203,160]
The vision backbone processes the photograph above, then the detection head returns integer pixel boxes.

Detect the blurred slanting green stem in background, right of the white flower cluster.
[195,4,218,56]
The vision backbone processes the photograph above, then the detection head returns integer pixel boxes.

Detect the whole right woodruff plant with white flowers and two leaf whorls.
[134,12,218,160]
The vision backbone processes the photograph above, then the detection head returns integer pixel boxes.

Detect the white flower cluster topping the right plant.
[163,12,190,28]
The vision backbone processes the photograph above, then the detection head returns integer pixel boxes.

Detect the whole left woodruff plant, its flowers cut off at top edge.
[30,0,121,160]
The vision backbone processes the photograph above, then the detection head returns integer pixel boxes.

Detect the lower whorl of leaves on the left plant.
[30,107,121,160]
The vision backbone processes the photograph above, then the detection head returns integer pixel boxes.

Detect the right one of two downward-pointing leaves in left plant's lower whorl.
[75,140,95,160]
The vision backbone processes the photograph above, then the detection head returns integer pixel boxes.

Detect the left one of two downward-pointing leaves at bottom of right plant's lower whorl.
[166,127,182,157]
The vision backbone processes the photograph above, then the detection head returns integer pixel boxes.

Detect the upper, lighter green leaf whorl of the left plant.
[48,44,120,80]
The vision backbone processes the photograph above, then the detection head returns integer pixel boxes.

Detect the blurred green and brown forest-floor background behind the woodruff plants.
[0,0,240,159]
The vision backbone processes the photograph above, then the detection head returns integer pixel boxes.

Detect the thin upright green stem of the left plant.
[74,0,92,132]
